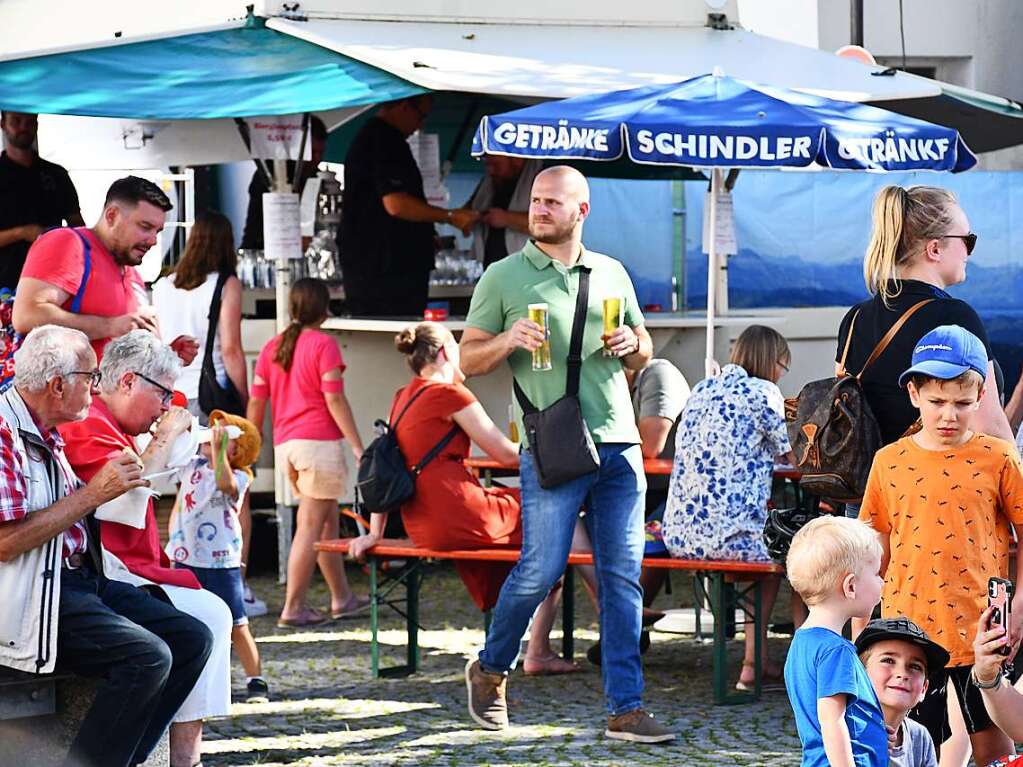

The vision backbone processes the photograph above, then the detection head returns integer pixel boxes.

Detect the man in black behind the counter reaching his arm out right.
[338,95,479,317]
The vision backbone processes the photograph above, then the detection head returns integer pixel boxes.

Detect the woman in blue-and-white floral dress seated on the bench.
[663,325,791,689]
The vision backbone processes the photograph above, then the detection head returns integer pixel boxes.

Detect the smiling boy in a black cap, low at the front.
[856,618,948,767]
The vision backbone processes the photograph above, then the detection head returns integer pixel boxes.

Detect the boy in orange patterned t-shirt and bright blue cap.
[859,325,1023,764]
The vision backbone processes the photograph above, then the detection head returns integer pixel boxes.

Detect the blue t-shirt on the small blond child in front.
[785,627,888,767]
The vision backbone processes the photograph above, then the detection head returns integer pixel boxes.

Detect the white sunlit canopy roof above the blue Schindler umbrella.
[267,18,941,101]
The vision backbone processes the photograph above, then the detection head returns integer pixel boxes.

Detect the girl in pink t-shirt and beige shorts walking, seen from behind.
[247,278,369,628]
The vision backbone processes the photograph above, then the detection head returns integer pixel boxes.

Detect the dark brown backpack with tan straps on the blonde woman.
[785,299,934,503]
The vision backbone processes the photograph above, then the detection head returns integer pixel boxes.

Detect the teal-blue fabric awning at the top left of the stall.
[0,20,426,120]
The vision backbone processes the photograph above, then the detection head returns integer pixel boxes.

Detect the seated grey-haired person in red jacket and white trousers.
[60,330,231,767]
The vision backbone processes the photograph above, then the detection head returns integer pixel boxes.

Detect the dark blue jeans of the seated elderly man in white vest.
[56,568,213,767]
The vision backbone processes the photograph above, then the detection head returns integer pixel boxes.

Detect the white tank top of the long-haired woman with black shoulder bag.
[152,272,227,400]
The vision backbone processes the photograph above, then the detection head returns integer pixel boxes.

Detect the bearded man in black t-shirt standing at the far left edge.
[0,111,85,290]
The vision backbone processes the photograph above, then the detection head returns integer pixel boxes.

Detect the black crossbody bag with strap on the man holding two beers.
[513,267,601,490]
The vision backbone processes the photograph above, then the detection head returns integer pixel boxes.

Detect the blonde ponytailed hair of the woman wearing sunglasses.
[863,185,957,306]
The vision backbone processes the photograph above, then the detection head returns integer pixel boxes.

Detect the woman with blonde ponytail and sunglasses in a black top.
[835,186,1013,445]
